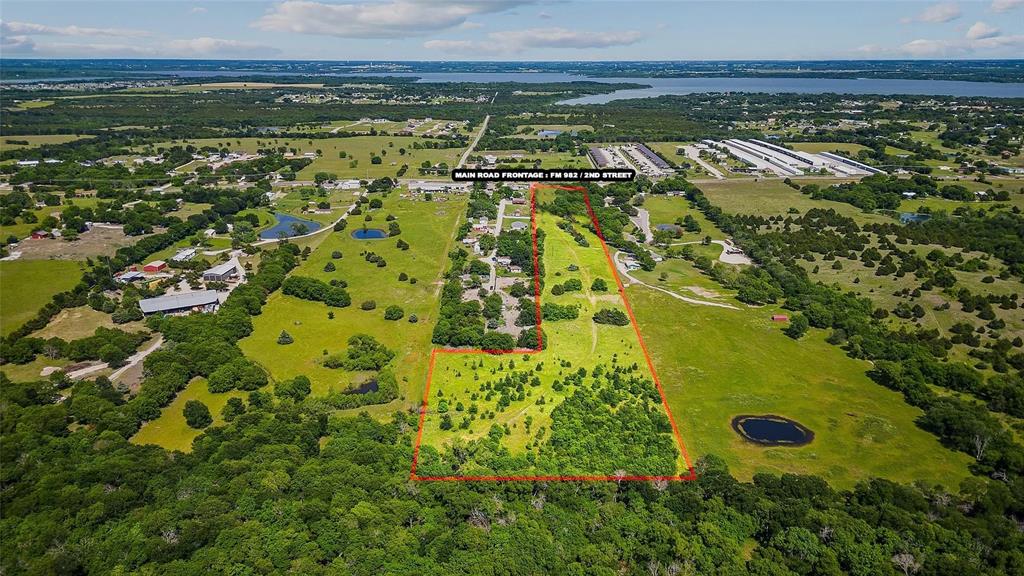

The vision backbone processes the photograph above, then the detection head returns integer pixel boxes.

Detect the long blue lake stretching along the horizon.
[146,70,1024,99]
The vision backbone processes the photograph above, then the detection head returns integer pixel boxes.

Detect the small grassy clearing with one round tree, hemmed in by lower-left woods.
[131,378,249,452]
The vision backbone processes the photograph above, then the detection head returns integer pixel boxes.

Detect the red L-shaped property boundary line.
[409,183,697,482]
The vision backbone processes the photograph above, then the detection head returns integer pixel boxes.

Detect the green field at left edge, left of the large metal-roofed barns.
[0,260,85,336]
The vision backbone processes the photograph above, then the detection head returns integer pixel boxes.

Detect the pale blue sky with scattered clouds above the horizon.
[0,0,1024,60]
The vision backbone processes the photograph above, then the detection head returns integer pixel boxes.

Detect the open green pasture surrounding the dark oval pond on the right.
[628,286,971,489]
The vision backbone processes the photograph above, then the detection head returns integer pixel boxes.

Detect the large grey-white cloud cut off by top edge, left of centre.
[252,0,527,38]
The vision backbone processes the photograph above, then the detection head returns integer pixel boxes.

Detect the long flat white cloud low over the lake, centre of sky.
[423,28,643,54]
